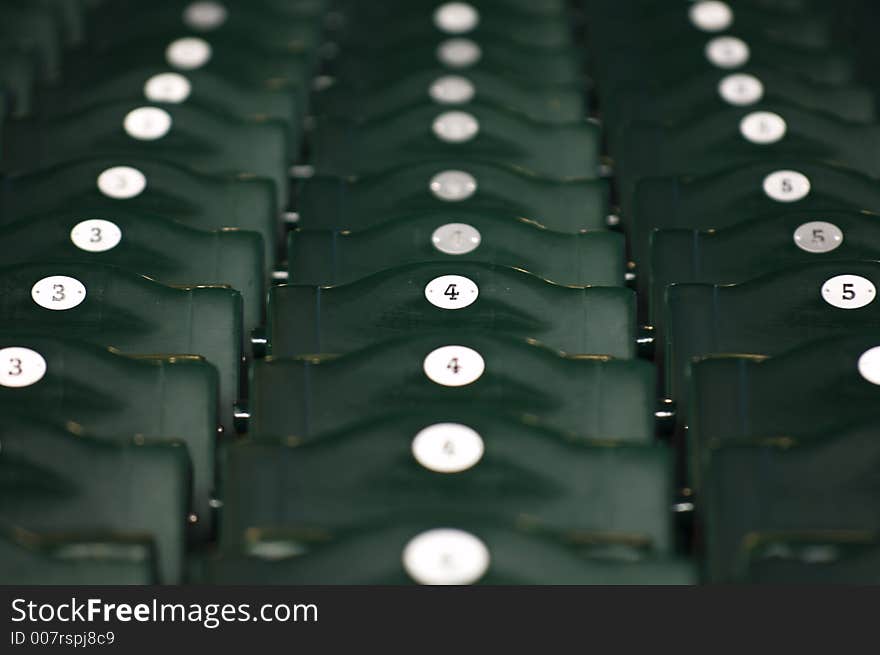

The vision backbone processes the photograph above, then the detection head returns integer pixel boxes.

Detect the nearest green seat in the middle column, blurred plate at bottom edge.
[208,512,696,585]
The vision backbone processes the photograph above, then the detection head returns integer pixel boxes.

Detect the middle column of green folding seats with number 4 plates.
[207,0,694,584]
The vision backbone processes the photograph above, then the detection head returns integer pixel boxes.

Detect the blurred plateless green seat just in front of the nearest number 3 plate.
[0,415,190,583]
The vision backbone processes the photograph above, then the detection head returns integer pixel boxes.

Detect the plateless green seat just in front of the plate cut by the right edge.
[701,421,880,582]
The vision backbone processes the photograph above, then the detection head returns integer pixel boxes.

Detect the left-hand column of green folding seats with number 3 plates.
[0,0,325,583]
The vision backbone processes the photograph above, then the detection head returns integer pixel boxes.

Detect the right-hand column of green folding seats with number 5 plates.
[587,0,880,582]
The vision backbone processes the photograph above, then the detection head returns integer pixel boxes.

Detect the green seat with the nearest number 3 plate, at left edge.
[0,331,218,537]
